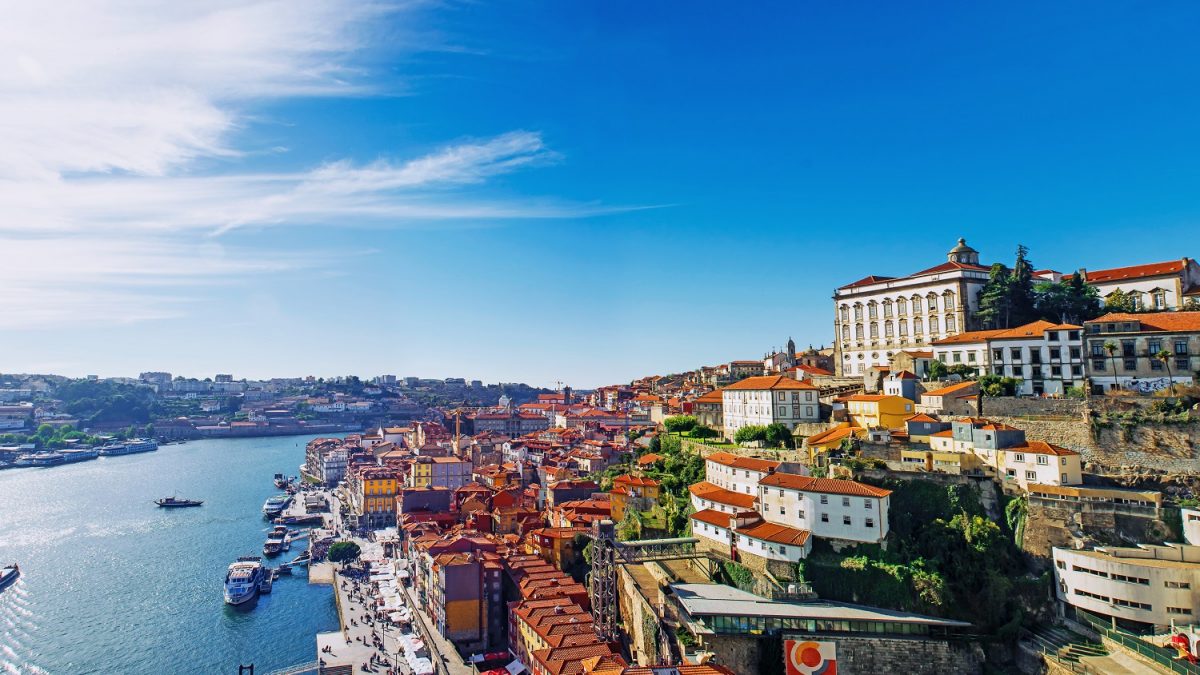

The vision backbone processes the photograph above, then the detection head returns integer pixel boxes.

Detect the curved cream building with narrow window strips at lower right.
[1054,544,1200,632]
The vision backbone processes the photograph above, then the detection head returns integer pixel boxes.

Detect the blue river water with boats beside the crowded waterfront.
[0,436,337,675]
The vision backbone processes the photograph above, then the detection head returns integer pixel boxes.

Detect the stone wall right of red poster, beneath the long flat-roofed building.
[787,635,984,675]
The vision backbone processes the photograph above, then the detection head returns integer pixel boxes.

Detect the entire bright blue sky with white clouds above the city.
[0,0,1200,388]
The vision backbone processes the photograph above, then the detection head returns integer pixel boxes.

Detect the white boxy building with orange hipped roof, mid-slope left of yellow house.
[721,375,821,441]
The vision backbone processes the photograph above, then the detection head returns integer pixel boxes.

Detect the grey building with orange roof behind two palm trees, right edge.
[1084,311,1200,394]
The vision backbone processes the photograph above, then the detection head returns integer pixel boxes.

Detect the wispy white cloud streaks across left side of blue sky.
[0,0,600,328]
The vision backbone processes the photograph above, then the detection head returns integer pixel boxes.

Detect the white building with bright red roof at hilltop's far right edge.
[1080,258,1200,311]
